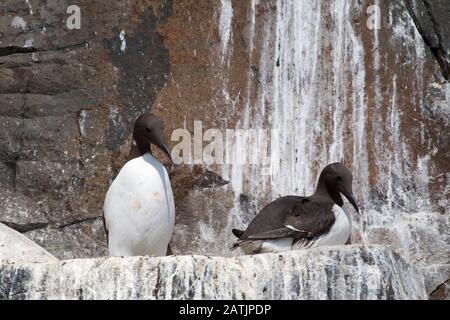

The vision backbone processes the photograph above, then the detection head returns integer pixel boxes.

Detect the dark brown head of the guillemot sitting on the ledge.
[314,162,359,212]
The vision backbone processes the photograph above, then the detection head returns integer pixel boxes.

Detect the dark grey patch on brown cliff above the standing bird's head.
[103,8,171,150]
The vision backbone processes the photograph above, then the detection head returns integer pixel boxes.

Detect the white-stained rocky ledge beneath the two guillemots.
[0,245,428,299]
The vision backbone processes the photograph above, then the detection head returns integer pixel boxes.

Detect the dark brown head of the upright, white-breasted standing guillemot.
[129,113,173,164]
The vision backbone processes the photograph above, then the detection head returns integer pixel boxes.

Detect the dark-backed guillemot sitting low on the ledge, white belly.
[233,162,359,254]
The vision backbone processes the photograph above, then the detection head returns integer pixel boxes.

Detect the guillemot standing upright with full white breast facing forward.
[103,114,175,256]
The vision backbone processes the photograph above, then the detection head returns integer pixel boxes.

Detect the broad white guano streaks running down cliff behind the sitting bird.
[213,0,442,254]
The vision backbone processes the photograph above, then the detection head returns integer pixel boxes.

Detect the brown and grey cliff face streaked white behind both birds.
[0,0,450,293]
